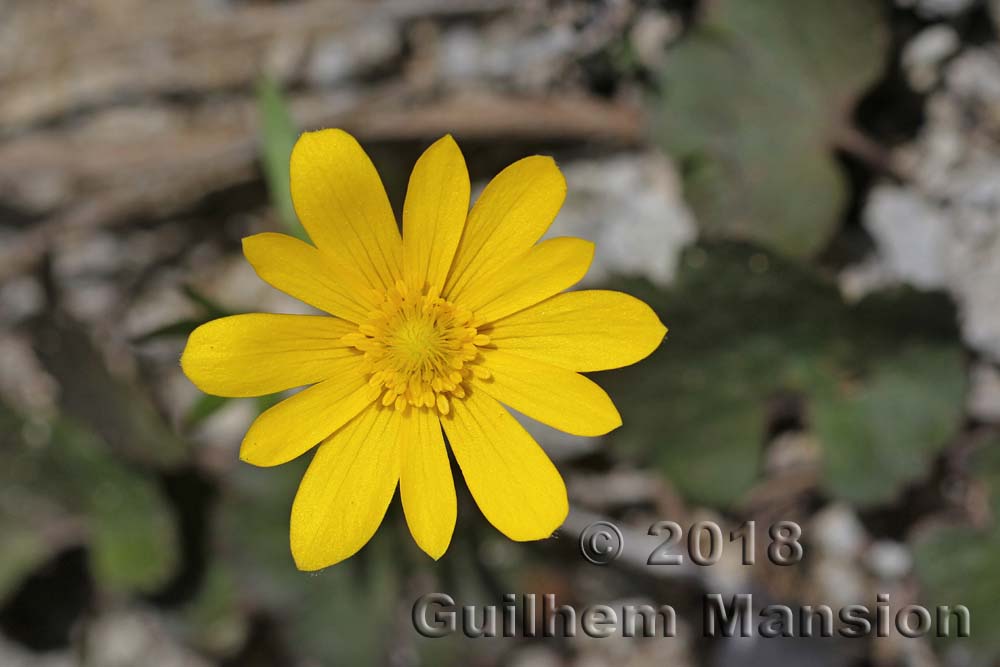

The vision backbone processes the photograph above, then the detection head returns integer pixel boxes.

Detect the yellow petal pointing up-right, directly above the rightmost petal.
[461,237,594,322]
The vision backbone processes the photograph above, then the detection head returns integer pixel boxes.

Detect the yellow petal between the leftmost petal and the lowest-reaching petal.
[240,357,375,466]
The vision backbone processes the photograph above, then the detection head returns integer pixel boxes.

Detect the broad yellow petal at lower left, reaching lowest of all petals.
[290,406,400,570]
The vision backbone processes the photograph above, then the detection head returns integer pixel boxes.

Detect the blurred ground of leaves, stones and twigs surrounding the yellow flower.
[0,0,1000,667]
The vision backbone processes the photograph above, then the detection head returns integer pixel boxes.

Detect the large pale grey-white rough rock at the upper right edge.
[856,49,1000,360]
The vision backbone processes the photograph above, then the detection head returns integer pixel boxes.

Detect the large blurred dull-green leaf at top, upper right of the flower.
[654,0,887,257]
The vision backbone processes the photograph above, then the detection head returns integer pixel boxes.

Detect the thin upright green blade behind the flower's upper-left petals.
[257,76,308,240]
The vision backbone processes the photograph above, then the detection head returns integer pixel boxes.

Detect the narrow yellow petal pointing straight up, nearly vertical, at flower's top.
[403,134,470,294]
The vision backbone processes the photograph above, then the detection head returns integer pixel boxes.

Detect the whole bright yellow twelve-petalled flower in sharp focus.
[181,130,666,570]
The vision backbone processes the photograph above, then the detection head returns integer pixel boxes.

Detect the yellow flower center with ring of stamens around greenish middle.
[344,281,490,415]
